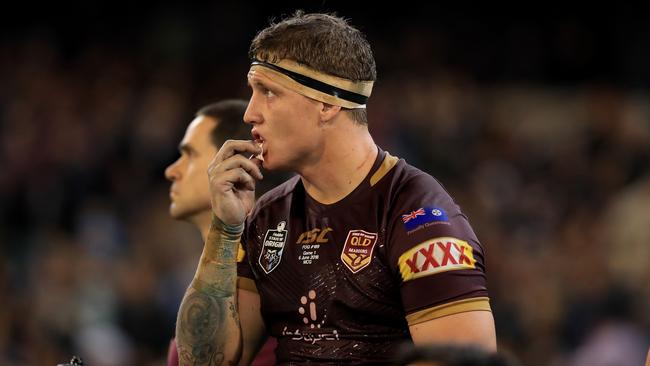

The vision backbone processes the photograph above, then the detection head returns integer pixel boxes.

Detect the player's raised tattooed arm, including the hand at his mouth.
[176,140,263,365]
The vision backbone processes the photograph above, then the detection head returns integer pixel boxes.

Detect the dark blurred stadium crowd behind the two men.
[0,1,650,366]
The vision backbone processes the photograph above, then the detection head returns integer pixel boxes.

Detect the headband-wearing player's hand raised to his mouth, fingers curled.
[208,140,263,226]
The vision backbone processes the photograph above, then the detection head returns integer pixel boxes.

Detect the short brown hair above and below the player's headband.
[248,10,377,124]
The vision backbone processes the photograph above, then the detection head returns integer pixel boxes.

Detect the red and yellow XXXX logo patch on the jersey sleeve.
[398,237,476,282]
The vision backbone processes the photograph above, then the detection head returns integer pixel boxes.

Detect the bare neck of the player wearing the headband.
[299,121,378,204]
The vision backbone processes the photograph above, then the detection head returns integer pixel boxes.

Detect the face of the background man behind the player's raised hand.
[165,116,217,221]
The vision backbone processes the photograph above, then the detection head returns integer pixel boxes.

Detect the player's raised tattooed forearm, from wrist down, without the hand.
[176,219,242,365]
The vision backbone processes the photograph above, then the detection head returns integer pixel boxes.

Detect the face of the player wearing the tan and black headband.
[244,69,323,171]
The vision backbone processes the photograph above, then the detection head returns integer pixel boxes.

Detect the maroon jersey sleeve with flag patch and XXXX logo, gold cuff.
[387,173,490,325]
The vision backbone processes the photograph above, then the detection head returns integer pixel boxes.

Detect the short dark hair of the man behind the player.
[196,99,251,149]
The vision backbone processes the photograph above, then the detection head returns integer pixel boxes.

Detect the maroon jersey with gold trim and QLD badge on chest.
[238,150,490,364]
